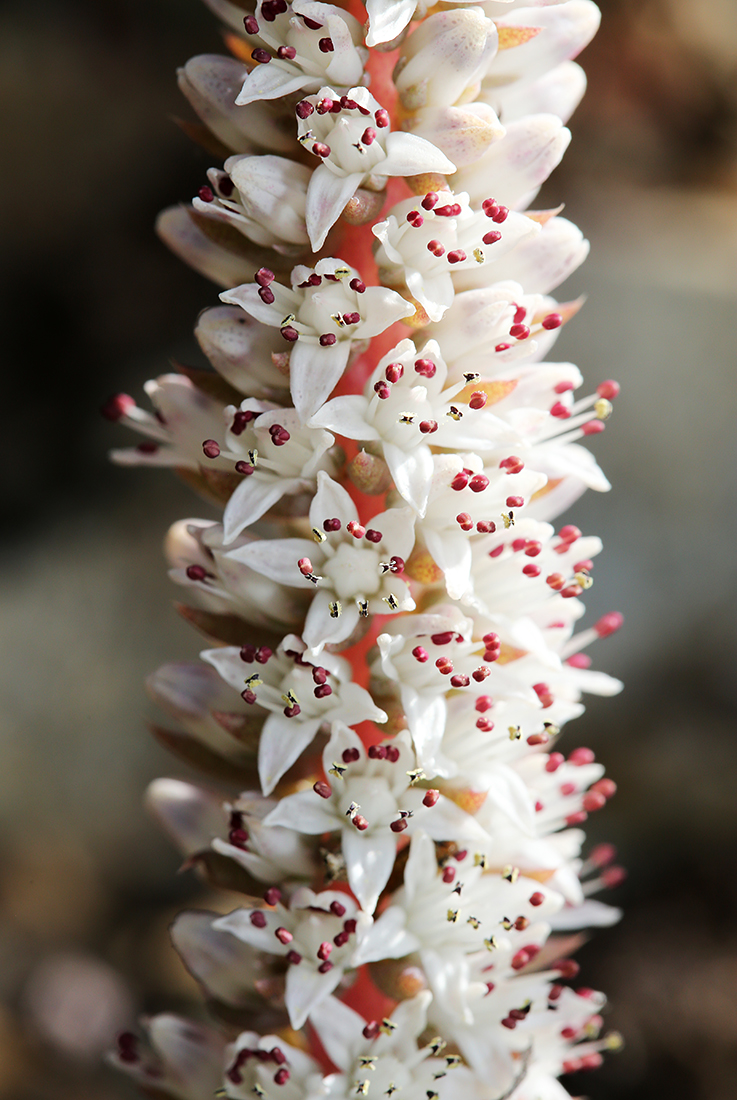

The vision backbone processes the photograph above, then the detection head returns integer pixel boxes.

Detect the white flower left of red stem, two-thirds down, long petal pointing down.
[201,635,386,794]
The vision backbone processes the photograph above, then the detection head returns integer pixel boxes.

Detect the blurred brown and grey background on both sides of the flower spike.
[0,0,737,1100]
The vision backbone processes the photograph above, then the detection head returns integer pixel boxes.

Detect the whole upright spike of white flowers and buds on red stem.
[106,0,623,1100]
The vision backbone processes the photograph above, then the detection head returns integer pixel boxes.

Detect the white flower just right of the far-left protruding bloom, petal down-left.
[215,398,338,543]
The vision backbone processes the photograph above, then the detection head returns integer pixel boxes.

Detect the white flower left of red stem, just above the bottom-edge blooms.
[212,887,400,1027]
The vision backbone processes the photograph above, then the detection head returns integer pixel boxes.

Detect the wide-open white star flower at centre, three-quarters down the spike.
[266,724,484,913]
